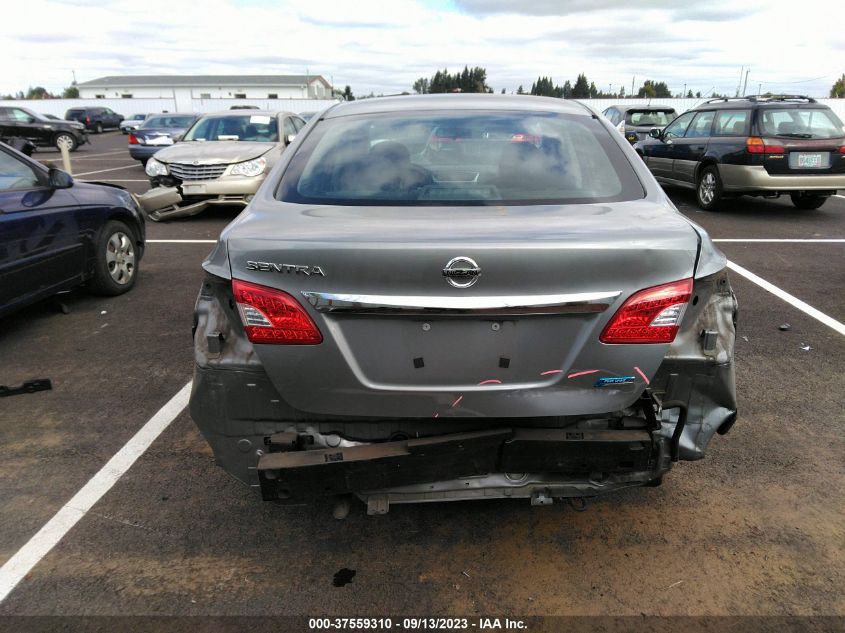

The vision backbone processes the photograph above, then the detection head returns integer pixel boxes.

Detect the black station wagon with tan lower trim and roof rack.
[634,95,845,210]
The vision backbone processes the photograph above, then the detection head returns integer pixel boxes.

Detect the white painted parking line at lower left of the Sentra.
[0,382,191,602]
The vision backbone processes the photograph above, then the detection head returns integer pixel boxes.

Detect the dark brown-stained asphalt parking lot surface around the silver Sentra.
[0,133,845,623]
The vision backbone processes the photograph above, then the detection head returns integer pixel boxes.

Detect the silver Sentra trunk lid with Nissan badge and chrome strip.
[224,200,698,417]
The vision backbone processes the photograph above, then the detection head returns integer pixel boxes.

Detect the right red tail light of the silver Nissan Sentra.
[599,279,692,343]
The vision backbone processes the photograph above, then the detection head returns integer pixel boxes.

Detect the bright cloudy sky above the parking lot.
[0,0,845,96]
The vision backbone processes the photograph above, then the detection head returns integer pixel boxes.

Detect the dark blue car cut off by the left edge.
[0,138,145,316]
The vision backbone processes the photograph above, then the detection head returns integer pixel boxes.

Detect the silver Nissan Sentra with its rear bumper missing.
[191,95,737,514]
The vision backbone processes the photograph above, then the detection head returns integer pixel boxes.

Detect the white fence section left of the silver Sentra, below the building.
[0,98,336,117]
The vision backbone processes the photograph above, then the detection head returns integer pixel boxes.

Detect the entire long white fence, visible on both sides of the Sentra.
[0,98,845,120]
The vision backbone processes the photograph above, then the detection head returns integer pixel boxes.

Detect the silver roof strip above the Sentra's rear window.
[323,93,593,119]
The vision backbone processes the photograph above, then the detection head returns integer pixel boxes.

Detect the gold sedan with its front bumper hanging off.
[139,110,305,221]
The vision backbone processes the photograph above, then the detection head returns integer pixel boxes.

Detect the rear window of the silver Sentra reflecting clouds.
[279,111,644,206]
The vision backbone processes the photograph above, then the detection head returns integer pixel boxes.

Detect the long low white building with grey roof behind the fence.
[77,75,332,112]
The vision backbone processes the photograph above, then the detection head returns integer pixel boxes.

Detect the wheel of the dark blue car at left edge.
[88,220,138,297]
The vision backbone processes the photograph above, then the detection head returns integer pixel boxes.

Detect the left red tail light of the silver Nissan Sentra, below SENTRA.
[232,279,323,345]
